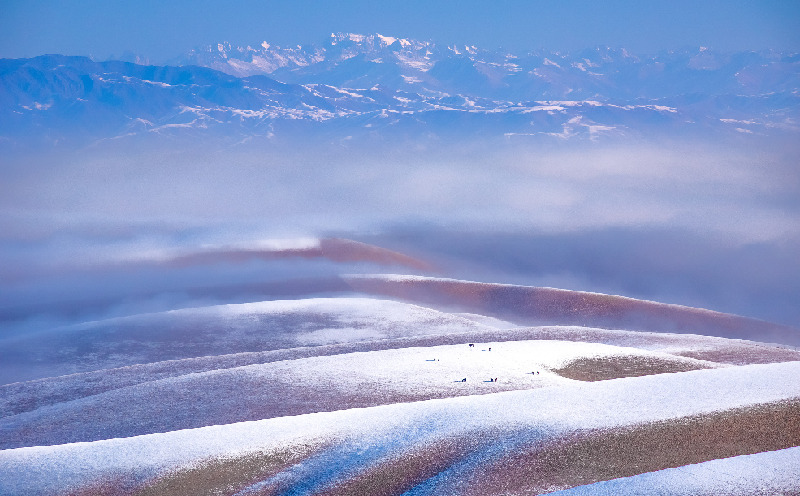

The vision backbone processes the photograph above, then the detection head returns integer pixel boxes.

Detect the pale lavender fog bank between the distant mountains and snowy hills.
[0,138,800,336]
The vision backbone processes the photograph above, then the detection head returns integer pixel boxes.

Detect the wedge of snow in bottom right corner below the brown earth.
[549,447,800,496]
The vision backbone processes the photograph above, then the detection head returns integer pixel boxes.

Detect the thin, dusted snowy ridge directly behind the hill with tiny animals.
[0,324,800,424]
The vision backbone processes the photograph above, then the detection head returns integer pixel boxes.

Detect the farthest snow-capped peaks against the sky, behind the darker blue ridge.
[180,33,798,101]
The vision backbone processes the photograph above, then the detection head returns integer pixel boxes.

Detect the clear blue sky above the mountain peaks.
[0,0,800,62]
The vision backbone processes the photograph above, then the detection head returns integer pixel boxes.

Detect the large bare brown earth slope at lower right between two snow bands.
[460,400,800,496]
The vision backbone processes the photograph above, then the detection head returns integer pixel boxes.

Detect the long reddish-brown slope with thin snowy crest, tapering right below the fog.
[346,275,800,346]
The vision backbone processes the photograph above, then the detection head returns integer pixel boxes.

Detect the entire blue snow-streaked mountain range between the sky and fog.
[0,33,800,144]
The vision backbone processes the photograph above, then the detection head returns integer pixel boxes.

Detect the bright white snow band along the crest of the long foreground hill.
[0,362,800,495]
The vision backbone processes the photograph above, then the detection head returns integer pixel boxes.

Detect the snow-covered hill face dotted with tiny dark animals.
[0,340,719,447]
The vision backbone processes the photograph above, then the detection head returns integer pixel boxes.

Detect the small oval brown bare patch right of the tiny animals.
[552,356,709,382]
